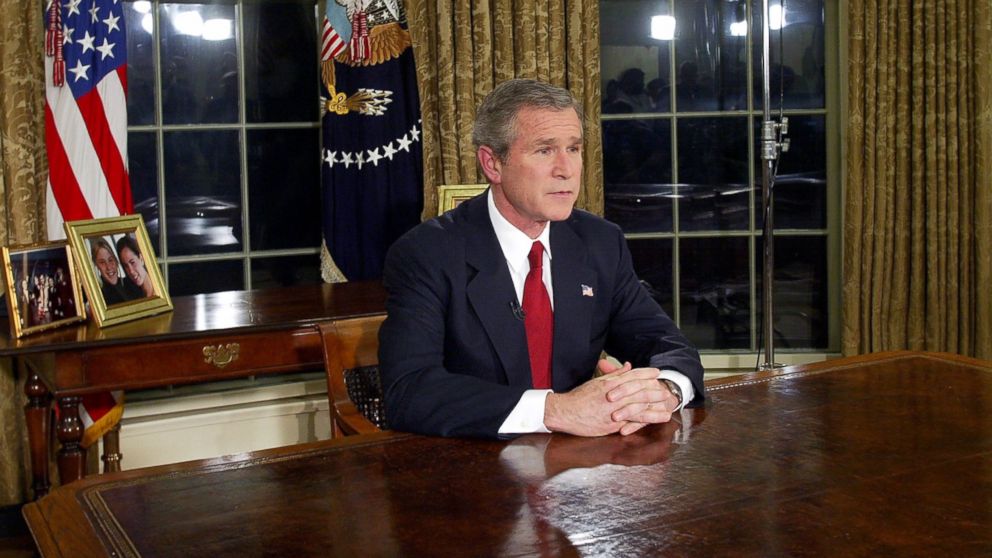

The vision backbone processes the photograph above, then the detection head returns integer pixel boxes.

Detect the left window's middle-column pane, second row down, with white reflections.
[165,130,242,256]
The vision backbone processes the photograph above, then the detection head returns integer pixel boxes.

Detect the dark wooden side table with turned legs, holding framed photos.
[0,281,386,497]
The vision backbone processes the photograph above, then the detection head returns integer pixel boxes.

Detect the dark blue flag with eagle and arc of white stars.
[321,0,423,281]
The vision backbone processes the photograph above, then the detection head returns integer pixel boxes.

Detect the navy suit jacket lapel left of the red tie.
[462,196,531,386]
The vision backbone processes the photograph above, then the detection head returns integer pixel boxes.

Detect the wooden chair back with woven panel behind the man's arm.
[317,315,389,438]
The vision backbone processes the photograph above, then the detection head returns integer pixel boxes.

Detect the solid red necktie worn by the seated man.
[524,241,554,389]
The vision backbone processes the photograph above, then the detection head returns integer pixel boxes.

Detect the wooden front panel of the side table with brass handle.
[71,329,323,391]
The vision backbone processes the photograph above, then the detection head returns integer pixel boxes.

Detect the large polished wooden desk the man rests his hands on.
[24,353,992,558]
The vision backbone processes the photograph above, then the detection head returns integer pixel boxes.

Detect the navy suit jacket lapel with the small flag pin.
[551,220,606,392]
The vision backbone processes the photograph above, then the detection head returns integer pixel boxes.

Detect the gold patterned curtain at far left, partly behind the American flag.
[0,0,48,506]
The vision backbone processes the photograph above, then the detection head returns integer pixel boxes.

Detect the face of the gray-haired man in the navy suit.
[479,107,582,238]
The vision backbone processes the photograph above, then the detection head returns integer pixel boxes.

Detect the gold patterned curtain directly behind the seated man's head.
[406,0,603,218]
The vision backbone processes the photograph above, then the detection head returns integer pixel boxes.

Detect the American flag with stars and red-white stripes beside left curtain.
[45,0,134,447]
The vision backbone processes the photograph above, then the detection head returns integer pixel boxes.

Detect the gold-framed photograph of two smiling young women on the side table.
[65,215,172,327]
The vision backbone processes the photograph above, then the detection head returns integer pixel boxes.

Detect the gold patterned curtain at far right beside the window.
[843,0,992,359]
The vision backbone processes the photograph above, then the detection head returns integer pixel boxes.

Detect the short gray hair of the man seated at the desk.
[472,79,582,161]
